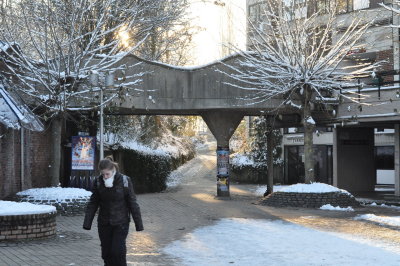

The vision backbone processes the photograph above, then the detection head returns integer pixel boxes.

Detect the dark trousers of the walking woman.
[98,223,129,266]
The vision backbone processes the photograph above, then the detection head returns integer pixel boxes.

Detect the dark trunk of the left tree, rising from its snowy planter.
[49,116,62,187]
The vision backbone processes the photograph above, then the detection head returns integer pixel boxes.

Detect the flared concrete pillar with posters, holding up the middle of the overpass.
[201,111,243,197]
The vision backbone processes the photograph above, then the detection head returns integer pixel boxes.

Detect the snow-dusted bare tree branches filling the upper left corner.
[0,0,191,117]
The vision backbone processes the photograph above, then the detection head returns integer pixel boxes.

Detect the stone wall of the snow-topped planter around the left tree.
[18,197,90,216]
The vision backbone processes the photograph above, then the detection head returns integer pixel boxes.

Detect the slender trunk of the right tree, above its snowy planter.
[303,86,315,183]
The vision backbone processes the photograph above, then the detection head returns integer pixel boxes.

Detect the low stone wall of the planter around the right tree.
[261,192,360,208]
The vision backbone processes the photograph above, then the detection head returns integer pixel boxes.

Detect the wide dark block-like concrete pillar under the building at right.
[333,127,376,192]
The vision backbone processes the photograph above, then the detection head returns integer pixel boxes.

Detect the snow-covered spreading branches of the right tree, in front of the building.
[219,0,377,111]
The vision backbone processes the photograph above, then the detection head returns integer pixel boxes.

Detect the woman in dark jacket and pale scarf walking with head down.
[83,158,144,266]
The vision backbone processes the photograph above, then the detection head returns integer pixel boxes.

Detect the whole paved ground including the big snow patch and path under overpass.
[0,141,400,266]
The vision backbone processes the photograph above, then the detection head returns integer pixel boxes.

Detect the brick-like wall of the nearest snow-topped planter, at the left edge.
[0,212,57,241]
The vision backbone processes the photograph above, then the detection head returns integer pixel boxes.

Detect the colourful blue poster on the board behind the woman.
[71,136,96,170]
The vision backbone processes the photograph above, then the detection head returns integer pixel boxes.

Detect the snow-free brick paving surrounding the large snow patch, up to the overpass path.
[0,144,400,266]
